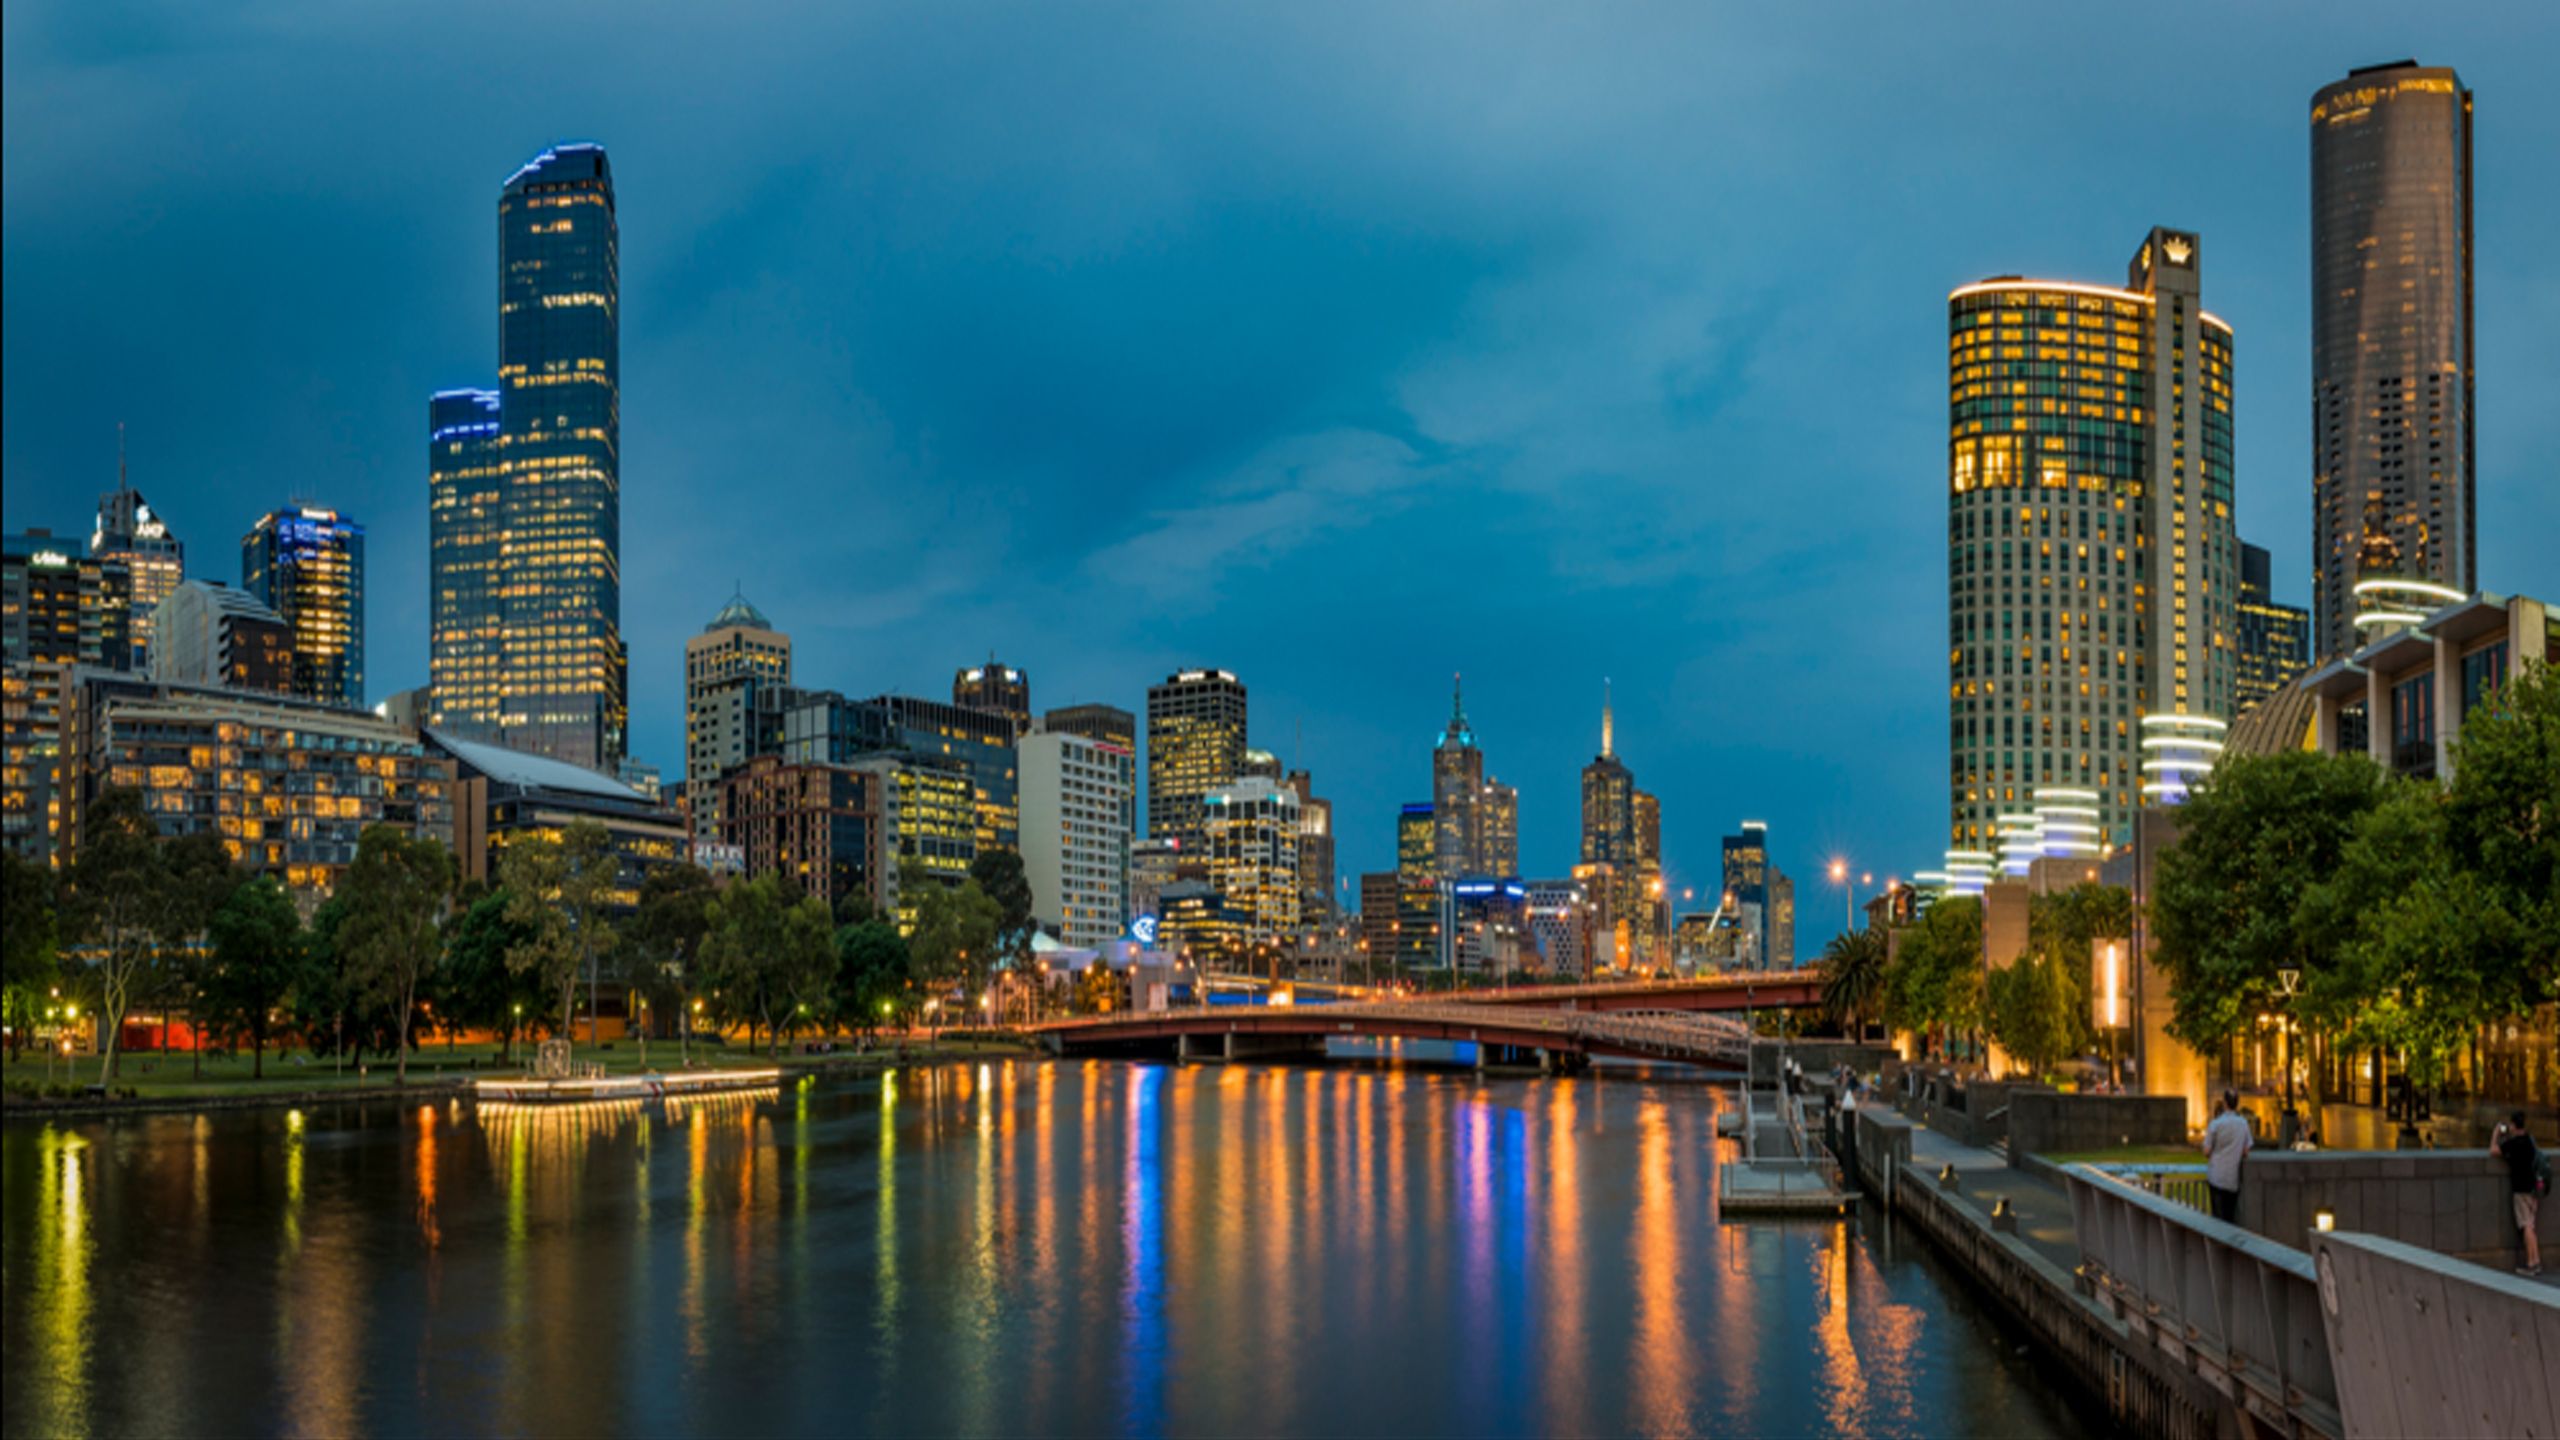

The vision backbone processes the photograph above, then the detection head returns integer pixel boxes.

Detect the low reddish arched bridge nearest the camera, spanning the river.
[1032,999,1751,1071]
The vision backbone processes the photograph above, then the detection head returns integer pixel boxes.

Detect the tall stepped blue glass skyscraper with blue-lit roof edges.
[428,143,627,771]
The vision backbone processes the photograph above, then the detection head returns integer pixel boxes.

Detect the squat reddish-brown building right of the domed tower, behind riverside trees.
[716,753,891,910]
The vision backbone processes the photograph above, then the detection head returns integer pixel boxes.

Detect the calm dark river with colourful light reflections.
[0,1061,2079,1435]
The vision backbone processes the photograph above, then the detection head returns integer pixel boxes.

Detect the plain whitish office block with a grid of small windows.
[1021,730,1137,951]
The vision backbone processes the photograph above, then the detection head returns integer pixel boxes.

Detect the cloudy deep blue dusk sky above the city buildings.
[0,0,2560,915]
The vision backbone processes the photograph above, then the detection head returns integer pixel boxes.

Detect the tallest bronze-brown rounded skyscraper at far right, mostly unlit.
[2312,59,2478,656]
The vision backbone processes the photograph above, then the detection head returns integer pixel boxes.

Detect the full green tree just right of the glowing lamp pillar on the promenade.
[2150,751,2383,1053]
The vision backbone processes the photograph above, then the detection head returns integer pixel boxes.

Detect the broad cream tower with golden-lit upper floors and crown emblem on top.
[1946,228,2240,851]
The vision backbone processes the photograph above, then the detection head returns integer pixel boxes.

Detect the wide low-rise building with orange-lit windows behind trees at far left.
[61,669,456,892]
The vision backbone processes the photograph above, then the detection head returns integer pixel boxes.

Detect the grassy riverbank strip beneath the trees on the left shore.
[0,1035,1037,1122]
